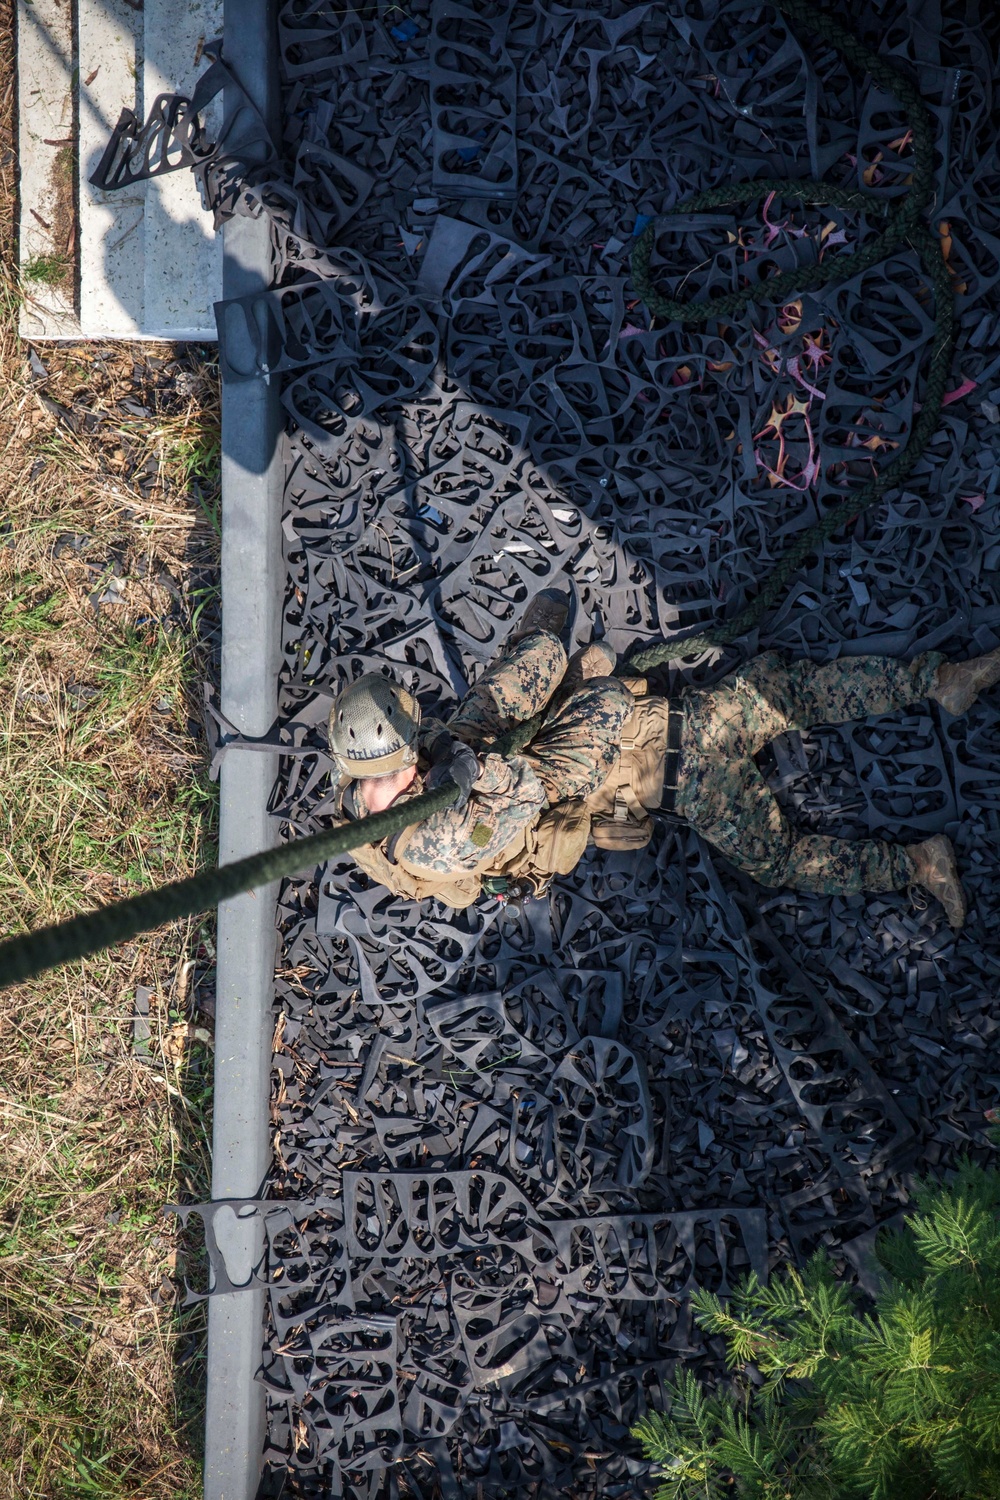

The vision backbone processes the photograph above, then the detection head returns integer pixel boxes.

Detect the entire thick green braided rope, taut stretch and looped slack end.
[0,0,955,989]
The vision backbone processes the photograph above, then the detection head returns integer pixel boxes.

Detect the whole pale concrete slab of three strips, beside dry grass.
[18,0,222,341]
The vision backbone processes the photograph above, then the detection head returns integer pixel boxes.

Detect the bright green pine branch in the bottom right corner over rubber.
[634,1163,1000,1500]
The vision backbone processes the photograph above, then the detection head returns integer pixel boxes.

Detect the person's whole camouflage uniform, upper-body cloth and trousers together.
[350,630,945,896]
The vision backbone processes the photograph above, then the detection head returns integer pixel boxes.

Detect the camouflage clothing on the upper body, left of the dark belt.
[406,630,634,873]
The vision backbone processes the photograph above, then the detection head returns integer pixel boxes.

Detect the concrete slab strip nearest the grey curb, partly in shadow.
[142,0,222,339]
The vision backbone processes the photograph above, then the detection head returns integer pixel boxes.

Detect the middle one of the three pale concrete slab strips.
[78,0,145,339]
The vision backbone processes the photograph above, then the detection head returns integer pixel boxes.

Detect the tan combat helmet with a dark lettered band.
[330,672,420,777]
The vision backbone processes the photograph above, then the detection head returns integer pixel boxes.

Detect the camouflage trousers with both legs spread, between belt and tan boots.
[676,651,945,896]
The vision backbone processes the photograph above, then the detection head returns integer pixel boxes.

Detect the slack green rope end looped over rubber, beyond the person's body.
[625,0,955,672]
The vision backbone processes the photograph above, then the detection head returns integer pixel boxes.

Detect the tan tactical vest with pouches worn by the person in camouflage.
[341,678,667,911]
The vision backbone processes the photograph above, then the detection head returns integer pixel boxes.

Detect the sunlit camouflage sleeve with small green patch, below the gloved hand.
[396,755,549,875]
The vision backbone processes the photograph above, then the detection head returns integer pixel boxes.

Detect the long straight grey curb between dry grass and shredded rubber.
[204,0,285,1500]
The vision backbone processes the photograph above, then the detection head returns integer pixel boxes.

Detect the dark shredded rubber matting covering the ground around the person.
[177,0,1000,1500]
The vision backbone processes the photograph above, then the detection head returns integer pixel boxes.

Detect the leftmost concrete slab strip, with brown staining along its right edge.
[16,0,79,339]
